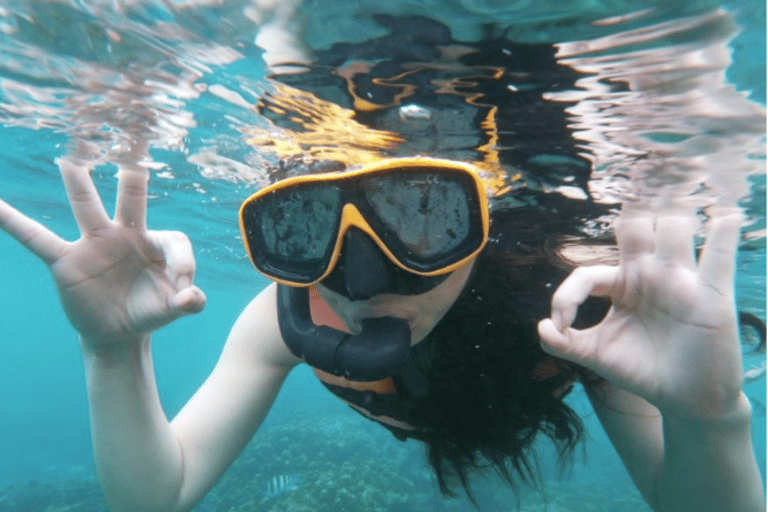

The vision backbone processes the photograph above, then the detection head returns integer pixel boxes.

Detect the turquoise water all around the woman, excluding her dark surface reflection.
[0,0,766,511]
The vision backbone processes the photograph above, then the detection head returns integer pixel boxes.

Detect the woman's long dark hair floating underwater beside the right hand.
[412,196,608,499]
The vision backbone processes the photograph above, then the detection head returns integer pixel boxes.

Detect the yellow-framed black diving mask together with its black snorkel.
[240,157,489,381]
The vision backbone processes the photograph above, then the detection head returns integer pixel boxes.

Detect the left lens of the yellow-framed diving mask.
[245,185,341,282]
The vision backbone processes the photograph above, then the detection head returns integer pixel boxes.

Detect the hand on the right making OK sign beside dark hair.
[539,208,742,421]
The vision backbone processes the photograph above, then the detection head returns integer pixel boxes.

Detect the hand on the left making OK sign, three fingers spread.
[0,146,205,350]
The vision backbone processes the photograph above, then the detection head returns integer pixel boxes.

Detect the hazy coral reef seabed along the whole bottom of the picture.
[0,414,650,512]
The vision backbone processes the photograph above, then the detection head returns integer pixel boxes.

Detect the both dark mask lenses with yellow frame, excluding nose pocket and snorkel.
[240,159,488,288]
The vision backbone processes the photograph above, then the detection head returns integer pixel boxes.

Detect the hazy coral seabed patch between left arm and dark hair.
[199,417,418,512]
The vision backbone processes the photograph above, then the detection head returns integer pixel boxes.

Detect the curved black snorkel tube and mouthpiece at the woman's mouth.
[277,285,411,381]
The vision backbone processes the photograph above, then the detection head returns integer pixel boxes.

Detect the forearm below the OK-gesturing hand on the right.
[652,393,765,512]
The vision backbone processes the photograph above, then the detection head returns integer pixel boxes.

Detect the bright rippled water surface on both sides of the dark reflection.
[0,0,765,276]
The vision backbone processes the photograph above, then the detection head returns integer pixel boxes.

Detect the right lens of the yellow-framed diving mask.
[364,171,470,259]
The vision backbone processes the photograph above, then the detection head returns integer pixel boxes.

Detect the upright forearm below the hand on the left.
[83,336,183,511]
